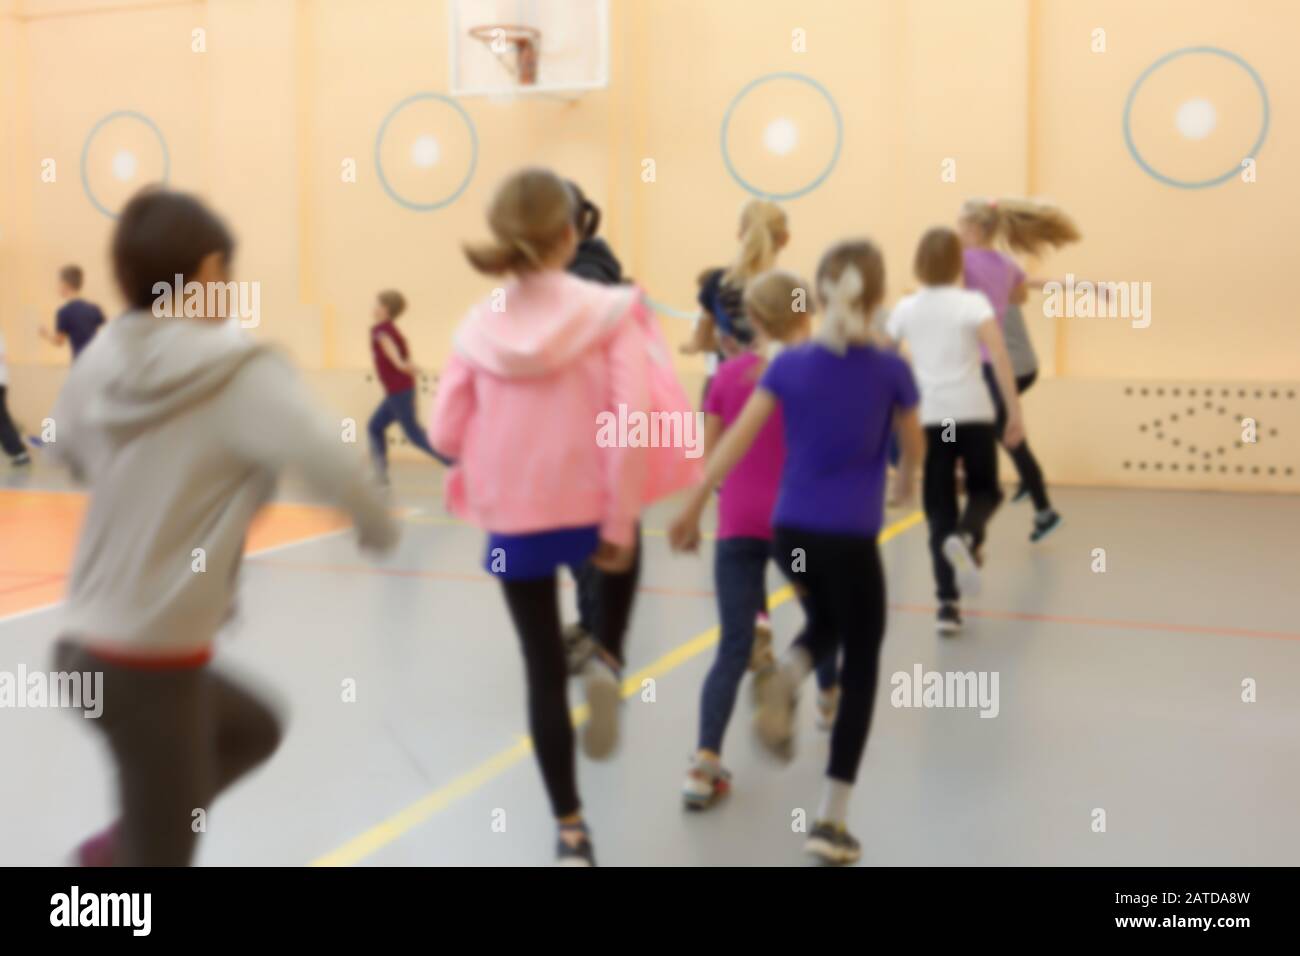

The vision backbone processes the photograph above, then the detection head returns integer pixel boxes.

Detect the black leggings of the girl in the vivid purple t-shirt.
[772,527,885,783]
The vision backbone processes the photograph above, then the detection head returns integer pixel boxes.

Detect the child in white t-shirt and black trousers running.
[888,229,1023,635]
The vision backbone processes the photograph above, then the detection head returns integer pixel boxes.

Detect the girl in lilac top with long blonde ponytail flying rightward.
[957,199,1080,541]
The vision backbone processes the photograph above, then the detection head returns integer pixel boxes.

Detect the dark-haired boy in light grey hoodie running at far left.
[49,189,397,866]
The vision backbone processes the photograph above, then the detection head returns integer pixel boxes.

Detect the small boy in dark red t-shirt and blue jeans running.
[365,289,450,485]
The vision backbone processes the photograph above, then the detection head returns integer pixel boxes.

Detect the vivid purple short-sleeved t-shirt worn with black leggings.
[761,342,918,536]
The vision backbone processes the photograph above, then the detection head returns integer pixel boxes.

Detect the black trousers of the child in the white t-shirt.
[922,424,1002,601]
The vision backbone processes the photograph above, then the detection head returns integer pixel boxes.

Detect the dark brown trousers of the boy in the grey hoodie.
[55,640,281,866]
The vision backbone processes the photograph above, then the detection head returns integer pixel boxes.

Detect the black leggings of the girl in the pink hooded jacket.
[502,544,641,818]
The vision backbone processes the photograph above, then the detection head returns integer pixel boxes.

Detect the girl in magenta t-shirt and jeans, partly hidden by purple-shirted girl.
[683,269,811,809]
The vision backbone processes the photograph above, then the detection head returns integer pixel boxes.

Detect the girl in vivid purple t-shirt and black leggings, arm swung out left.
[670,239,924,864]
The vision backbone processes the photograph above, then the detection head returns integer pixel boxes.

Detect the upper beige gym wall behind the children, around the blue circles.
[0,0,1300,486]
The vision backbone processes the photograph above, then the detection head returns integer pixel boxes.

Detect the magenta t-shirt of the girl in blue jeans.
[705,352,785,540]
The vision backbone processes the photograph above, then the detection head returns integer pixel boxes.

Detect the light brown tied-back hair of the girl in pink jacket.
[463,169,573,276]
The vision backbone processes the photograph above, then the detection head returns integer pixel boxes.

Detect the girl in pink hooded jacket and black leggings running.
[429,169,660,866]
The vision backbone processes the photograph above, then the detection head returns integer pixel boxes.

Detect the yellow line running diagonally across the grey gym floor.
[311,511,926,866]
